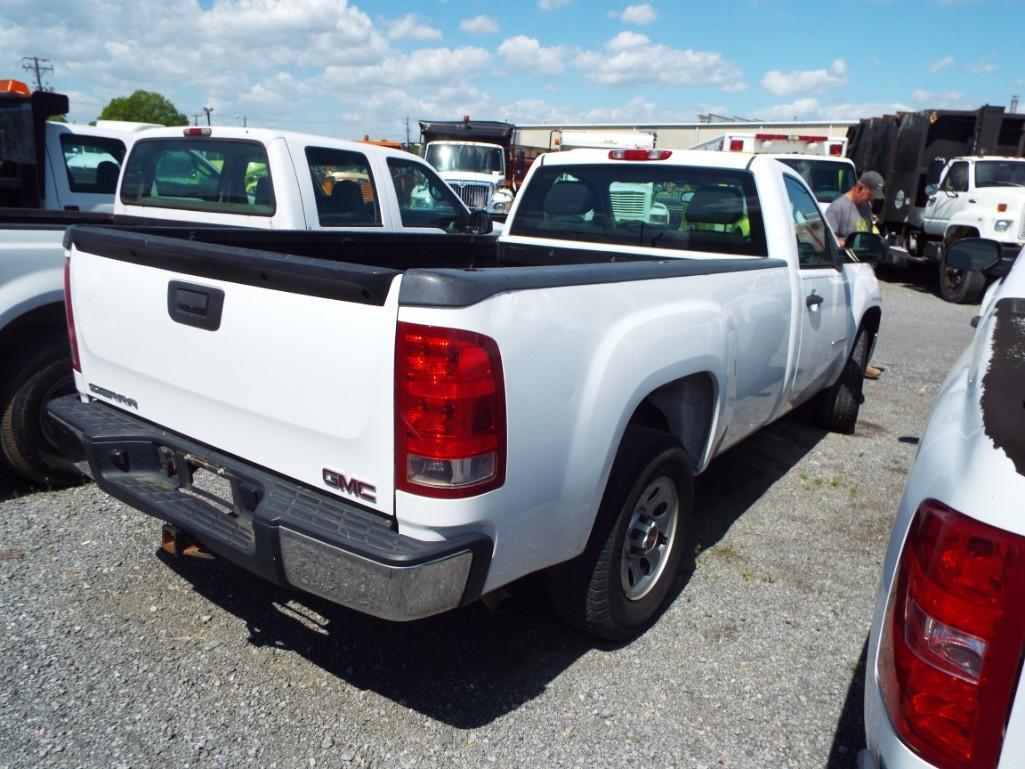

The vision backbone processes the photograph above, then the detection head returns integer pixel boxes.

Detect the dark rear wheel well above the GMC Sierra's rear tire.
[630,373,715,470]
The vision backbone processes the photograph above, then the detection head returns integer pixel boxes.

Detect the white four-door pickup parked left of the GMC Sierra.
[0,124,491,484]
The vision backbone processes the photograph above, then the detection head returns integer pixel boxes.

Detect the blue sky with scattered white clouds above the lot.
[0,0,1025,138]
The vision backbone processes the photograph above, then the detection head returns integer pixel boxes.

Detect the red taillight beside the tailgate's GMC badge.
[395,323,505,497]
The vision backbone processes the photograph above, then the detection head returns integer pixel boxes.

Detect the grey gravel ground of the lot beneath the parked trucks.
[0,271,976,769]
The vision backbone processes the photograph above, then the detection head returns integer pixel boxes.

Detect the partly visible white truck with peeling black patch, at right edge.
[858,238,1025,769]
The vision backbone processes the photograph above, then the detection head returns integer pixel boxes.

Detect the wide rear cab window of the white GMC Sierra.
[509,161,767,256]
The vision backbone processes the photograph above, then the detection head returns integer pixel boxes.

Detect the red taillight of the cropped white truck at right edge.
[878,500,1025,769]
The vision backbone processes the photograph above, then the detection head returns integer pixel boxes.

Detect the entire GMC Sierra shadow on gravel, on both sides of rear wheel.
[158,418,826,729]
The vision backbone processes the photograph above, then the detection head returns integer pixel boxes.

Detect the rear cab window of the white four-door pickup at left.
[121,137,275,216]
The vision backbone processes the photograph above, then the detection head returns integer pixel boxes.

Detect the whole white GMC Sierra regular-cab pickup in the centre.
[49,150,885,639]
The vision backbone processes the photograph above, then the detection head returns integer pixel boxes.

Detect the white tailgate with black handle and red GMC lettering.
[69,231,400,514]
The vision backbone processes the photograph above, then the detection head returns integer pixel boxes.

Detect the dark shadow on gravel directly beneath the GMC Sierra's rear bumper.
[158,551,593,729]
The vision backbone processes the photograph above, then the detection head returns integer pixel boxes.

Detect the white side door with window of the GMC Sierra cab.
[783,175,849,401]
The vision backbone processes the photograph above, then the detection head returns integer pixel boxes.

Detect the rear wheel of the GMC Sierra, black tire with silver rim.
[547,426,694,641]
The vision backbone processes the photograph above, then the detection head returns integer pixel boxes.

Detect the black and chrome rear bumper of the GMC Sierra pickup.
[48,395,492,621]
